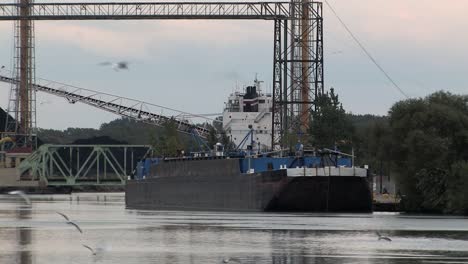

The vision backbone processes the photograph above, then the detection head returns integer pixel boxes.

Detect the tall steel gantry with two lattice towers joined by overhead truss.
[0,0,323,149]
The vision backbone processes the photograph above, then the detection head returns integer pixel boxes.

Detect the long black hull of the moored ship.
[126,160,372,212]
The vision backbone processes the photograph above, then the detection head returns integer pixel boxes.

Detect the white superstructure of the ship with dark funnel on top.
[223,79,273,151]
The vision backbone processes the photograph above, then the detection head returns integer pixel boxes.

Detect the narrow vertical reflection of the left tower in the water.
[16,206,32,264]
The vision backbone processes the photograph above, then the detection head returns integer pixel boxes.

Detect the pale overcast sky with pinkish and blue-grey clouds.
[0,0,468,129]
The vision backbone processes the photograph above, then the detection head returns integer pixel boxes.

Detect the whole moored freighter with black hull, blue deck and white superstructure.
[125,81,372,212]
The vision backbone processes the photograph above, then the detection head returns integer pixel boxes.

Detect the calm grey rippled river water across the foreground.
[0,193,468,264]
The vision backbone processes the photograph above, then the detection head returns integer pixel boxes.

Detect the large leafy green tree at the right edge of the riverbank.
[389,92,468,213]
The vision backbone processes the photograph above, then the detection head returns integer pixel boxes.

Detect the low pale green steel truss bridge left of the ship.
[18,145,152,186]
